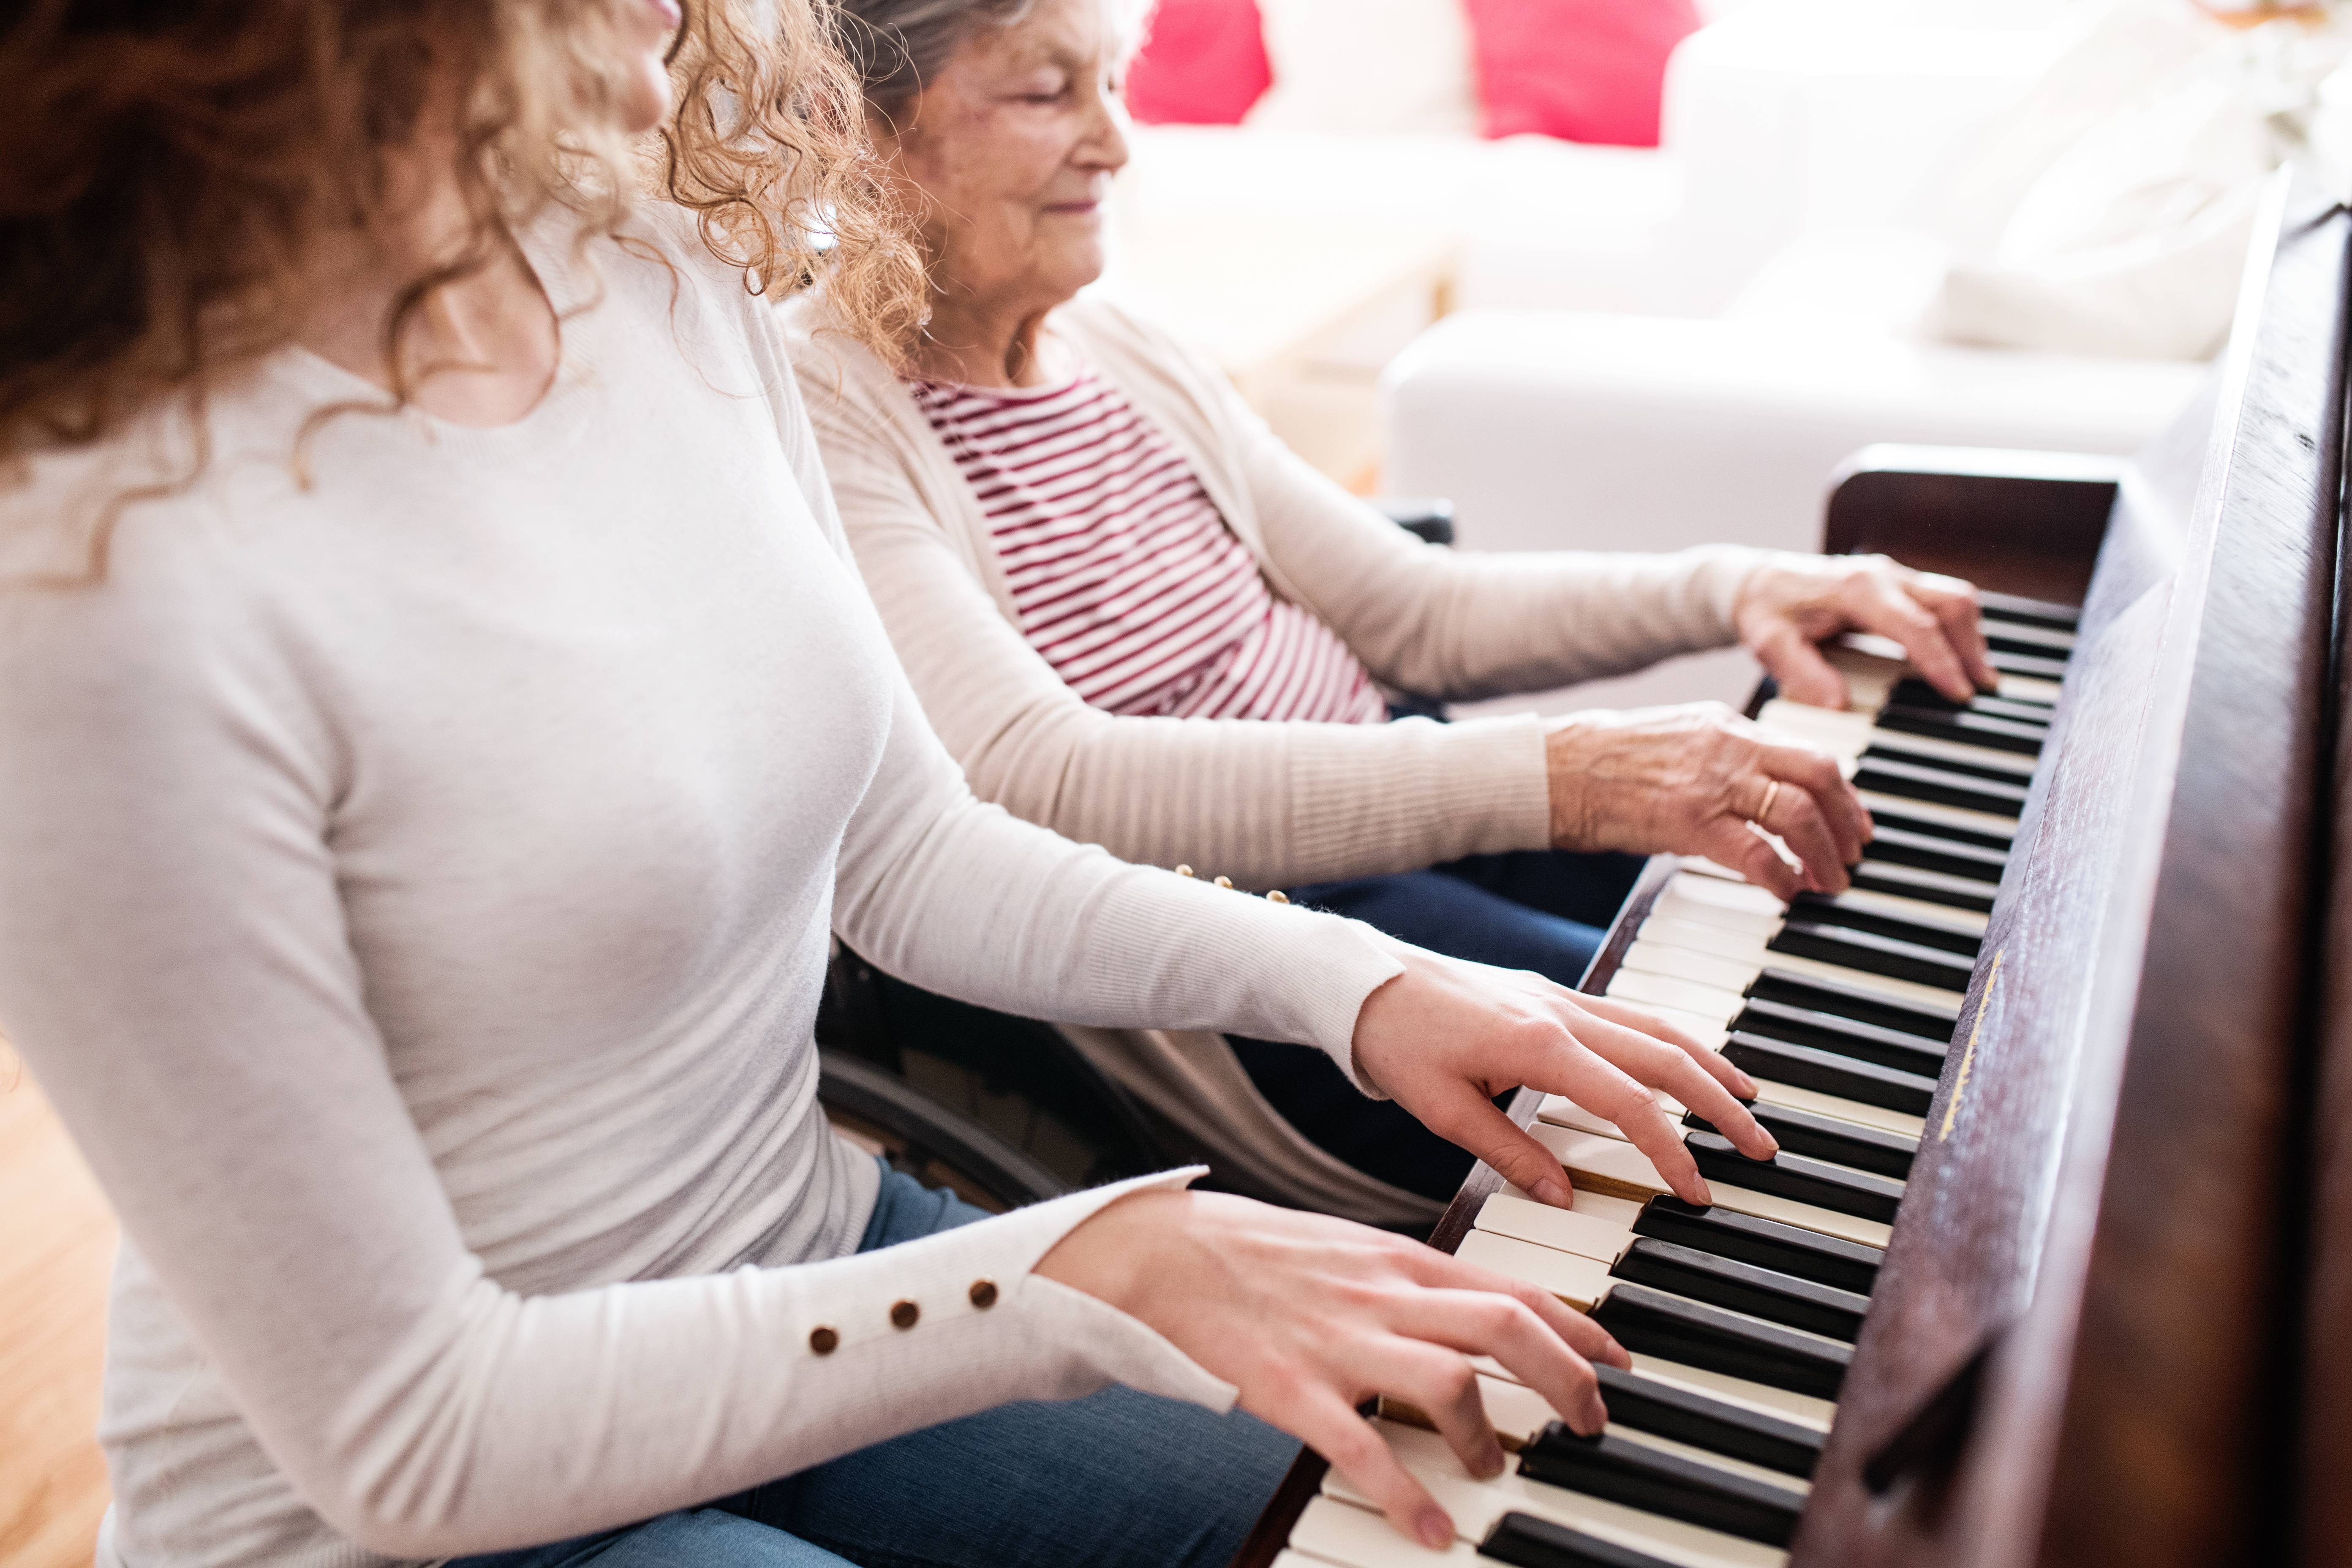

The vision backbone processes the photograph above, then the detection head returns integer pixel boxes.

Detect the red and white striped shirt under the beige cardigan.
[912,367,1388,724]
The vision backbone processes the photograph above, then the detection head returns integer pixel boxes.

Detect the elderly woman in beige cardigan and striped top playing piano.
[792,0,1992,1206]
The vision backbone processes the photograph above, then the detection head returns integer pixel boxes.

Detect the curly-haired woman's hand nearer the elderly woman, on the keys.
[1355,943,1780,1209]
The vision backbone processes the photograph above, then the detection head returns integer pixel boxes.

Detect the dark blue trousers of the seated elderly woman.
[1233,851,1642,1201]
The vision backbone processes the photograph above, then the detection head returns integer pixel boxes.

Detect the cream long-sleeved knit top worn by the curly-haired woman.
[0,211,1397,1568]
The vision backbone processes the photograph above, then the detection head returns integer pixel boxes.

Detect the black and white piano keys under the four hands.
[1275,595,2074,1568]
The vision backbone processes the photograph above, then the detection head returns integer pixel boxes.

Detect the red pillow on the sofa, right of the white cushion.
[1465,0,1698,148]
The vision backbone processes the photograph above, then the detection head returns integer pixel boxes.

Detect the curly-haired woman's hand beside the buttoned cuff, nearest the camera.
[1037,1194,1630,1549]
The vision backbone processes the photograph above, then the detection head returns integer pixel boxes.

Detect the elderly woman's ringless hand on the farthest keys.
[1731,555,1997,708]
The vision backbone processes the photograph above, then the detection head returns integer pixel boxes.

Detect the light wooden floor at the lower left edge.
[0,1041,115,1568]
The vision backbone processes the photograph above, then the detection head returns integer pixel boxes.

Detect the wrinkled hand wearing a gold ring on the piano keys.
[1543,700,1870,898]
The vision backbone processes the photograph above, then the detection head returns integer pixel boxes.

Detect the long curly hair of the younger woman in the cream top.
[0,0,922,576]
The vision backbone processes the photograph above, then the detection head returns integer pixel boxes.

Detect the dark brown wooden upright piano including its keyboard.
[1237,179,2352,1568]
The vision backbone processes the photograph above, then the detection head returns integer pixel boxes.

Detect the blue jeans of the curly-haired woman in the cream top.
[449,1168,1298,1568]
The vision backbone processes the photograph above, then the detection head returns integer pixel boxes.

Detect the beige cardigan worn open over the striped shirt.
[786,291,1767,1220]
